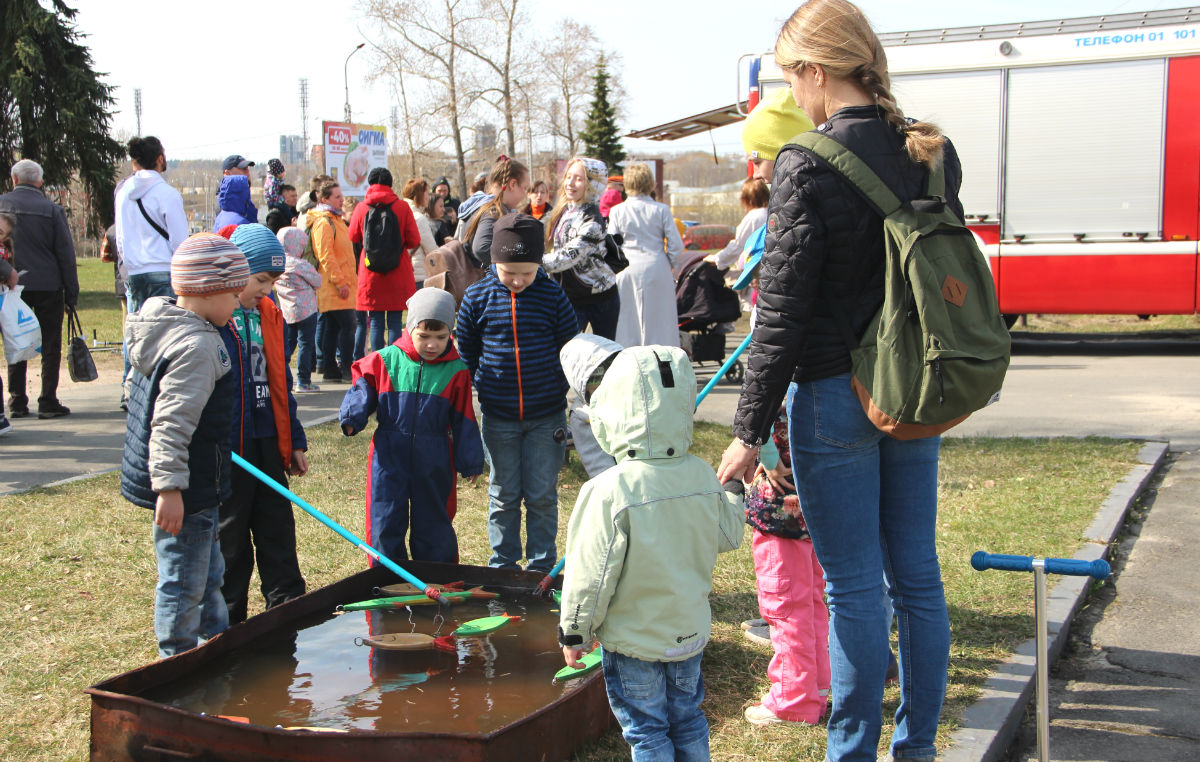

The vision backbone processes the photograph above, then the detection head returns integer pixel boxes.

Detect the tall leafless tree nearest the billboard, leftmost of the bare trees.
[362,0,480,194]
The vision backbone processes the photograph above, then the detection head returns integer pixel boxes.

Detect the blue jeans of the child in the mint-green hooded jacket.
[602,650,708,762]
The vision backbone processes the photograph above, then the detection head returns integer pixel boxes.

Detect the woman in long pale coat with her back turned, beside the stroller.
[608,163,683,347]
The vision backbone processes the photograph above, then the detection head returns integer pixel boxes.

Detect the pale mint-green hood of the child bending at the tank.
[592,347,696,463]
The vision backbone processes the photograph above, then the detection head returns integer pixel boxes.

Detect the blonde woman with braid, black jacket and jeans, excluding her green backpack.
[718,0,962,762]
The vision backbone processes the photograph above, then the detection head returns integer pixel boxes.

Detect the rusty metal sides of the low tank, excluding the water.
[86,562,614,762]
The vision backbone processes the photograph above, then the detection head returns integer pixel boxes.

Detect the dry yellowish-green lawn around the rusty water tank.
[0,424,1138,761]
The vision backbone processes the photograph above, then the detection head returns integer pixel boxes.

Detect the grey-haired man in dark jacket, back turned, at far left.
[0,158,79,418]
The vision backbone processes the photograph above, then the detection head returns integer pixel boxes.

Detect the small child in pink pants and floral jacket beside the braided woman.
[745,409,829,725]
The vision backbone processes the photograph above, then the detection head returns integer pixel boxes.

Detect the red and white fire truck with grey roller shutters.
[739,8,1200,314]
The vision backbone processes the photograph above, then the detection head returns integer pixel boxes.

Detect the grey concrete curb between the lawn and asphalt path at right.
[938,442,1170,762]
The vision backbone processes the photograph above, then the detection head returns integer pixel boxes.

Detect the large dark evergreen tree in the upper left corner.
[0,0,122,232]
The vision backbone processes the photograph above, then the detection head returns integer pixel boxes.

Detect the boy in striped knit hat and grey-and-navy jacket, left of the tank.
[121,233,250,658]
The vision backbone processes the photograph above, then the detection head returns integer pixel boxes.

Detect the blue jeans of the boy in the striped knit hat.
[154,508,229,659]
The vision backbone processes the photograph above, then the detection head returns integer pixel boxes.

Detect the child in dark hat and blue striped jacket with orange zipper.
[457,212,578,572]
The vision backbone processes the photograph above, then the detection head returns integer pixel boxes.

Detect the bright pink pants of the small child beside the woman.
[754,530,829,724]
